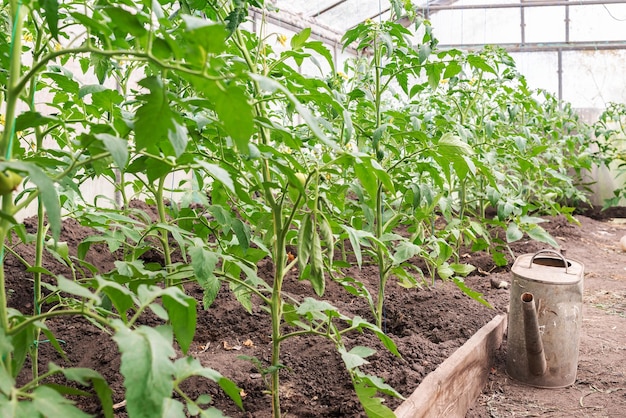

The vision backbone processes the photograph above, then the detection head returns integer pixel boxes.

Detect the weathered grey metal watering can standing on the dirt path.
[506,250,584,388]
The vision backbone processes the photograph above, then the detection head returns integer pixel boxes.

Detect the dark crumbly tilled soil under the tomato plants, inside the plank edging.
[5,205,626,417]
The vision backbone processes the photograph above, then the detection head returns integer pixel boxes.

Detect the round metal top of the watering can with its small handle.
[511,250,584,284]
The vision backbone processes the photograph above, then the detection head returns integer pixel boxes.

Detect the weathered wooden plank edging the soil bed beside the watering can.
[395,314,507,418]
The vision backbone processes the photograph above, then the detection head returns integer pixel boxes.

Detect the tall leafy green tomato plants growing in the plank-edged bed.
[0,0,615,417]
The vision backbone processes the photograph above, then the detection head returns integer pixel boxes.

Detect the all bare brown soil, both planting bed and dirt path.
[5,207,626,417]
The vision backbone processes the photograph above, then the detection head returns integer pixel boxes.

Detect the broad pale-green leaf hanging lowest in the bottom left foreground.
[112,323,176,418]
